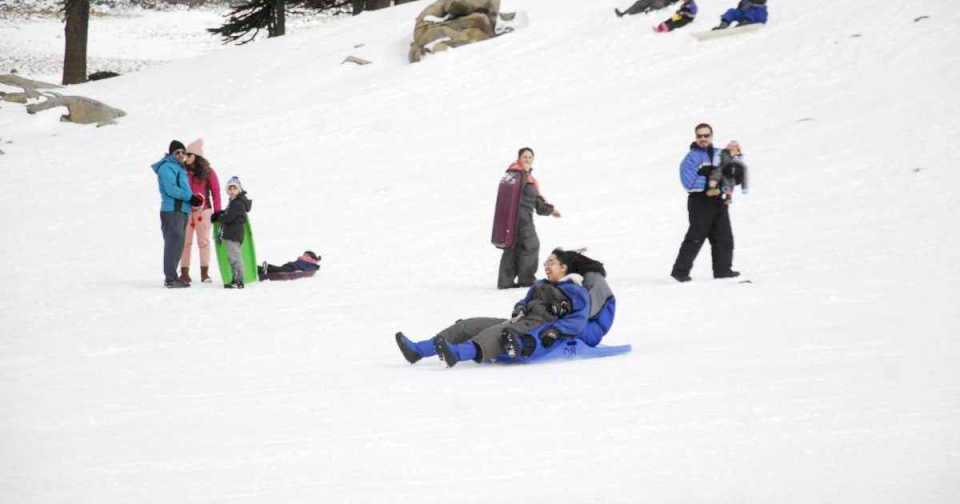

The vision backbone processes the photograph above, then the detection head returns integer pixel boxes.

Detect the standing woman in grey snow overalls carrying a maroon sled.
[497,147,560,289]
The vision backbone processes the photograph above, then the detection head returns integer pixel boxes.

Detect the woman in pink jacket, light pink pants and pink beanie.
[180,138,221,283]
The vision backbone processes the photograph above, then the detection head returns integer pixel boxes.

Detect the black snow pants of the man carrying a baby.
[672,192,733,276]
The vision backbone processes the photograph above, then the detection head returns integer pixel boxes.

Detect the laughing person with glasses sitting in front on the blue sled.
[396,249,588,367]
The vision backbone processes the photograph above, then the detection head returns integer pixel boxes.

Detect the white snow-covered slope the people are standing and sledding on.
[0,0,960,503]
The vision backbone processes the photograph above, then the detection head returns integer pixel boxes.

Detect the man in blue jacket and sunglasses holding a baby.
[670,123,740,282]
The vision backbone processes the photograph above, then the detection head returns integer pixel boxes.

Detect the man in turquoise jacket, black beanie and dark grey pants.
[152,140,202,289]
